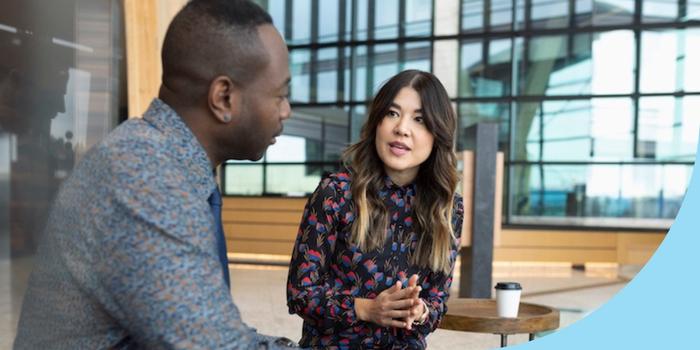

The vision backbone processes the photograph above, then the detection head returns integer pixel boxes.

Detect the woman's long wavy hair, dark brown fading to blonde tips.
[343,70,458,273]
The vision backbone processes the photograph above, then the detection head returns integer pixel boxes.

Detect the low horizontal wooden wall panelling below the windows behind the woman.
[223,193,665,264]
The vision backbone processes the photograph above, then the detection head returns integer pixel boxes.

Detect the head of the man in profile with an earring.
[160,0,291,164]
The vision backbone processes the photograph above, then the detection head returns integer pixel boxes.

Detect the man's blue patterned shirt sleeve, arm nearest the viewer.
[91,143,292,349]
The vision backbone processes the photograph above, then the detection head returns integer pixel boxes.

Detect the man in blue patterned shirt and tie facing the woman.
[15,0,291,349]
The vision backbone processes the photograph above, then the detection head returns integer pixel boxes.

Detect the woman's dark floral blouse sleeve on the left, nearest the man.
[287,178,357,334]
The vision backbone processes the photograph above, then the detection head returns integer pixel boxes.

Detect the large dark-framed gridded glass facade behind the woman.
[225,0,700,228]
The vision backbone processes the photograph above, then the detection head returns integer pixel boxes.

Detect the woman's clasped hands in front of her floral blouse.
[355,275,426,330]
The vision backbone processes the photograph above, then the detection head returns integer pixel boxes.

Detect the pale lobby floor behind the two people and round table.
[0,260,640,349]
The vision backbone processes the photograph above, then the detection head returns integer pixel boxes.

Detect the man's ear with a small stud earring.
[207,75,241,124]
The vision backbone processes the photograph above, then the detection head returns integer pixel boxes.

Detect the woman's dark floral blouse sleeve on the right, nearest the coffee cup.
[415,197,464,335]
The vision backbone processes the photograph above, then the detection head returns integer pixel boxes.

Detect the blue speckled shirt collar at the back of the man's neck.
[143,98,217,199]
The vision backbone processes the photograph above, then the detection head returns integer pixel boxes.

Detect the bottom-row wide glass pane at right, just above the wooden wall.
[511,164,692,220]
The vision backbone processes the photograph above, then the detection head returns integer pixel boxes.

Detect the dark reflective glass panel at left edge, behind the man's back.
[0,0,122,280]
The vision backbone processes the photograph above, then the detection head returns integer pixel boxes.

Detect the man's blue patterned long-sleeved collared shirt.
[15,99,292,349]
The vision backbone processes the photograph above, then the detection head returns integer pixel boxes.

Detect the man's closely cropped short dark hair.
[161,0,272,100]
